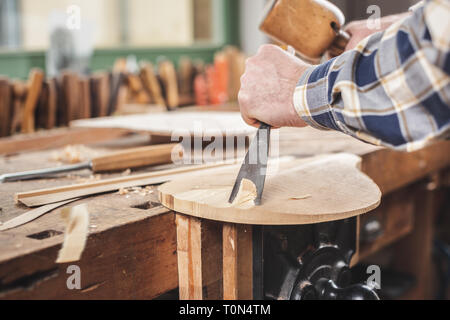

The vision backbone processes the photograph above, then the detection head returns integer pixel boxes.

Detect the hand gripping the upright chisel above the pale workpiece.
[239,45,310,128]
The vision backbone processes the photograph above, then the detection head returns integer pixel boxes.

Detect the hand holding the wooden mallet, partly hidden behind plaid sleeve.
[344,12,411,51]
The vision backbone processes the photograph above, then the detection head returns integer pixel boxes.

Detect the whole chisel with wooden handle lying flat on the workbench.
[0,143,183,183]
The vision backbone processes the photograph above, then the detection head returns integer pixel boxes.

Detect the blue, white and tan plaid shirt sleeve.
[294,0,450,151]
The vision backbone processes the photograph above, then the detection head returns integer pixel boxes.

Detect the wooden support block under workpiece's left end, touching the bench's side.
[176,214,223,300]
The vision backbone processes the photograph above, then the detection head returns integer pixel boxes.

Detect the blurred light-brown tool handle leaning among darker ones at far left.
[22,69,44,133]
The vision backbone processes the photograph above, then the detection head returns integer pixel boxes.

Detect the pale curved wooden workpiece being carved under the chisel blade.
[159,154,381,225]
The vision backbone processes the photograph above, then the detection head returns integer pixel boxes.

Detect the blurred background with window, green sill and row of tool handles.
[0,0,422,137]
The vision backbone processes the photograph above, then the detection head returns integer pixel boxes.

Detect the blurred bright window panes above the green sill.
[0,0,221,50]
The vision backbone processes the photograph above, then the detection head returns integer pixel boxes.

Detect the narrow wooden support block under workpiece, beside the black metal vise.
[222,224,253,300]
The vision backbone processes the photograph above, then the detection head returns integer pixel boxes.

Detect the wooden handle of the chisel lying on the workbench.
[91,143,183,172]
